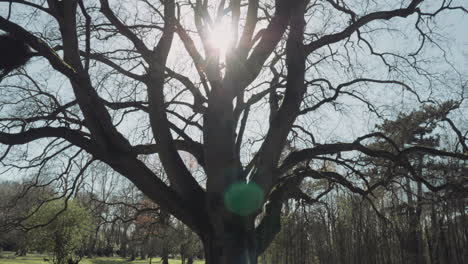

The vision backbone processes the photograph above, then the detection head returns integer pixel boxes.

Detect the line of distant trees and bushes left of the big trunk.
[0,173,203,263]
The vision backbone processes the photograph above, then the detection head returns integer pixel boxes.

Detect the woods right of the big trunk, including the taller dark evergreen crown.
[262,102,468,264]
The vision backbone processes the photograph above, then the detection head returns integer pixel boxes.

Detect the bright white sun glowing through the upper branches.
[208,21,233,58]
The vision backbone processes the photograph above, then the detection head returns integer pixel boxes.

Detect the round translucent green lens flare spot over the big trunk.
[224,182,263,216]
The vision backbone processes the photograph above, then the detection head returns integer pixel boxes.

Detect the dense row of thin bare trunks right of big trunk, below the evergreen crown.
[260,184,468,264]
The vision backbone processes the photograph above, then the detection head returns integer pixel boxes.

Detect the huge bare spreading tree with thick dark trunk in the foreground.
[0,0,468,263]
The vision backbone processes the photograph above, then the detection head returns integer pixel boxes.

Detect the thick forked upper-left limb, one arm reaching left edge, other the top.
[0,1,130,153]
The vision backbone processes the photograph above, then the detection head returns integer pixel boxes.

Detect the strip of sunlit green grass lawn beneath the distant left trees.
[0,252,205,264]
